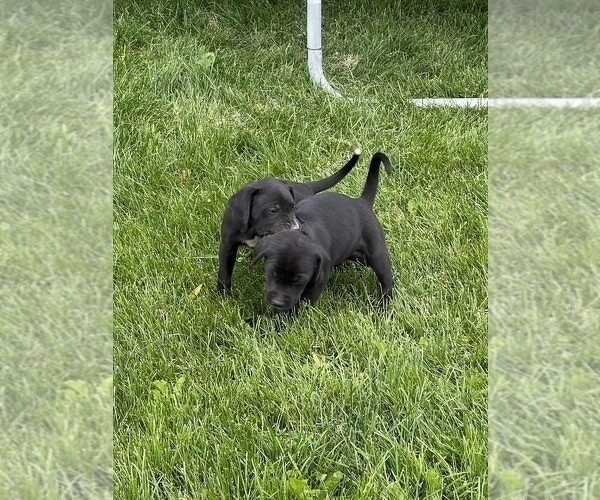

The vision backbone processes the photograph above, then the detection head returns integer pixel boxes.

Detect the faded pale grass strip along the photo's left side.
[0,2,112,499]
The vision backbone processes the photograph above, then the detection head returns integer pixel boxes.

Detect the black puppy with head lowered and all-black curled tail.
[254,153,394,312]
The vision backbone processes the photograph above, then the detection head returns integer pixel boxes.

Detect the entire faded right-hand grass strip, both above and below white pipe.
[489,0,600,499]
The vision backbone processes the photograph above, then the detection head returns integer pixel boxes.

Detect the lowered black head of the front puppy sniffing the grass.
[253,231,329,312]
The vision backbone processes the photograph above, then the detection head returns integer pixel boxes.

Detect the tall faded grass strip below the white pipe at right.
[489,110,600,499]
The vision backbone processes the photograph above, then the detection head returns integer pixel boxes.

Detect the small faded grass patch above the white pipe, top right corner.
[489,0,600,97]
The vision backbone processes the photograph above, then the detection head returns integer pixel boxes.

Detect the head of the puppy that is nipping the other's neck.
[228,179,300,242]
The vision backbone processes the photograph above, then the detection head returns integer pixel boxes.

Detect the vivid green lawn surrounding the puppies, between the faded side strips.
[114,1,487,499]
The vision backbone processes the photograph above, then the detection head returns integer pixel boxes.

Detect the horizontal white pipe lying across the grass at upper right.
[412,97,600,108]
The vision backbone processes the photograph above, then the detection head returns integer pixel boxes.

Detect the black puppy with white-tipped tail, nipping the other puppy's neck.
[217,149,360,292]
